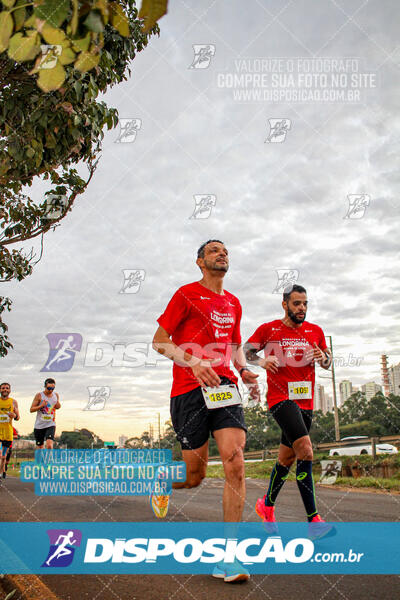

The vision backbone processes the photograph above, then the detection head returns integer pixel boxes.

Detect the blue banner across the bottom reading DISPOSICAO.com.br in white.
[0,522,400,574]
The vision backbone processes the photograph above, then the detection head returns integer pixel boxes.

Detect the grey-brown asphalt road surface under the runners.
[0,478,400,600]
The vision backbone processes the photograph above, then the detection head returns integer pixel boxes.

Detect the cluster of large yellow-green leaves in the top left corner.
[0,0,167,92]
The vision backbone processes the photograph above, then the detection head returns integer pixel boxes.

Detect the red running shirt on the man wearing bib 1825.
[157,281,242,397]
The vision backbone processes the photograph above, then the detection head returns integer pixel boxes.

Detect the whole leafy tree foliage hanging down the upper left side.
[0,0,159,356]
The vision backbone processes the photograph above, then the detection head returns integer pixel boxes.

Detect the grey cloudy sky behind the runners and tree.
[1,0,400,440]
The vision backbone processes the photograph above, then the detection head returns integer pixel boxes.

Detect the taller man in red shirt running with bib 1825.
[152,240,259,581]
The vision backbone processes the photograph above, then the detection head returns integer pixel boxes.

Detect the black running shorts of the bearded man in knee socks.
[269,400,313,448]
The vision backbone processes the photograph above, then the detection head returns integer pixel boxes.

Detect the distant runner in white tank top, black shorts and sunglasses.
[30,378,61,449]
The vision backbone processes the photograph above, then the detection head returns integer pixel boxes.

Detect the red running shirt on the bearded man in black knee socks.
[248,319,327,409]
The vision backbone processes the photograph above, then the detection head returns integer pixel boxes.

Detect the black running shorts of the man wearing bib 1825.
[170,377,247,450]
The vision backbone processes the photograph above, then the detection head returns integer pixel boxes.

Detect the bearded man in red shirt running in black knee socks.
[245,285,332,535]
